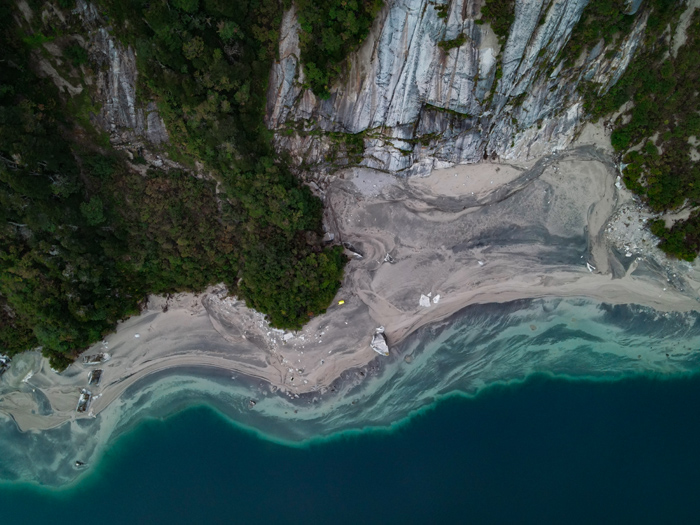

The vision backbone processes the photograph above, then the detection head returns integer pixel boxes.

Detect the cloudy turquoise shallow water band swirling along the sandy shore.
[0,300,700,490]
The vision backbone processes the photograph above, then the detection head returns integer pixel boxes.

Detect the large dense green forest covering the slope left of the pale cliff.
[0,0,346,369]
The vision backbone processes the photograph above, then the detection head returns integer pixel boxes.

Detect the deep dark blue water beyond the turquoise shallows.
[0,370,700,524]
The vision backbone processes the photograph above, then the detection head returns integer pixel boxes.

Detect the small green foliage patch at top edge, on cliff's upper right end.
[562,0,634,66]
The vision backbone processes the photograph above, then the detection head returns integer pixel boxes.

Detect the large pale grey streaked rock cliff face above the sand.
[267,0,647,174]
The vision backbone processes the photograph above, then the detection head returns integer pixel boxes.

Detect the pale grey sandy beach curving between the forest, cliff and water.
[0,125,700,430]
